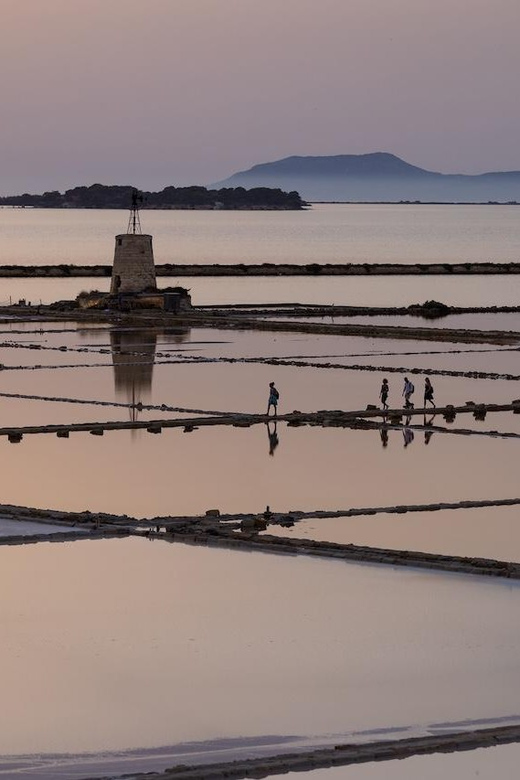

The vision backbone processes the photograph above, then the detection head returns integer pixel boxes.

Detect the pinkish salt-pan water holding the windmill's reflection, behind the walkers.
[0,324,520,431]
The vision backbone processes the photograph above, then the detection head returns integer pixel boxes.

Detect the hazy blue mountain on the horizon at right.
[212,152,520,203]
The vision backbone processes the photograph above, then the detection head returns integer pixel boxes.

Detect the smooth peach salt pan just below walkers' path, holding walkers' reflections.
[0,424,519,517]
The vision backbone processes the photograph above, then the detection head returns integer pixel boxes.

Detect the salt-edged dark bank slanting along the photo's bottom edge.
[0,716,520,780]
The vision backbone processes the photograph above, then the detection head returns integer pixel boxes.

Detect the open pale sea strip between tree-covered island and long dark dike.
[0,204,520,265]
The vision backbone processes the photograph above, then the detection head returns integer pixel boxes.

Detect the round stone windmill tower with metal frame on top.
[110,190,157,295]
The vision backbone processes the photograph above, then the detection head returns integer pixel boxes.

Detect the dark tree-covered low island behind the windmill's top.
[0,184,306,210]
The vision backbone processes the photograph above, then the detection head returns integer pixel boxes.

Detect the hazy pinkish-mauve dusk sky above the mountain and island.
[0,0,520,194]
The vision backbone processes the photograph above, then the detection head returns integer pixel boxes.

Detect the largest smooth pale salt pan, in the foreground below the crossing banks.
[0,539,520,755]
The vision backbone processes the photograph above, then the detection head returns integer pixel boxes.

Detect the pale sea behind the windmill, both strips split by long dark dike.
[0,204,520,306]
